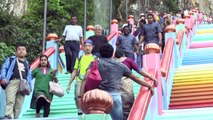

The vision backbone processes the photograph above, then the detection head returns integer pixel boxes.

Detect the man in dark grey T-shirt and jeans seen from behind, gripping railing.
[81,44,153,120]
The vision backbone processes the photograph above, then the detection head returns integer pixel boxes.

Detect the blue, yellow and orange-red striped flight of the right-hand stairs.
[169,48,213,109]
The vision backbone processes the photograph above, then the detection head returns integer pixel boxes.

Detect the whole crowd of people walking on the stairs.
[0,6,212,120]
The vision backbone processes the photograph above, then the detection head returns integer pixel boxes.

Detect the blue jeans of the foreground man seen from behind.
[108,92,123,120]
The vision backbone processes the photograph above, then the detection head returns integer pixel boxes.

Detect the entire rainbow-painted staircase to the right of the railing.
[158,26,213,120]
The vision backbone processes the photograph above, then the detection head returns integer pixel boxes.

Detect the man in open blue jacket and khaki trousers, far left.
[0,44,32,119]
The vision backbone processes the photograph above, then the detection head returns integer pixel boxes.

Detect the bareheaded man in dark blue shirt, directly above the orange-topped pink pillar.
[140,14,162,46]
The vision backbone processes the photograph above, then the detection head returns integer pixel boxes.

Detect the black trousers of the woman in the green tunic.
[36,97,50,117]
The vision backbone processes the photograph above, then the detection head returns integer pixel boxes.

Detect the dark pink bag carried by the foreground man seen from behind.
[85,60,102,91]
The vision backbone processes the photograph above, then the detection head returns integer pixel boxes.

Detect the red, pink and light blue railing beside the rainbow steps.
[128,8,199,120]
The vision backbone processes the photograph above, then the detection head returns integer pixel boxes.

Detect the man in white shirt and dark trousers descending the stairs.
[59,16,84,73]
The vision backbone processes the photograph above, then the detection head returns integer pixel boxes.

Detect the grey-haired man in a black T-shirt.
[88,25,108,57]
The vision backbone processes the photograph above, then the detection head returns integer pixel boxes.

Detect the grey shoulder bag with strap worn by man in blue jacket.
[16,59,30,95]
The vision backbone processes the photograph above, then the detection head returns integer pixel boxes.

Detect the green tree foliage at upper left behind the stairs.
[0,0,94,65]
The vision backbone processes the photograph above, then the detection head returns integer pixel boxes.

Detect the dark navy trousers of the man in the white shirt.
[64,41,80,73]
